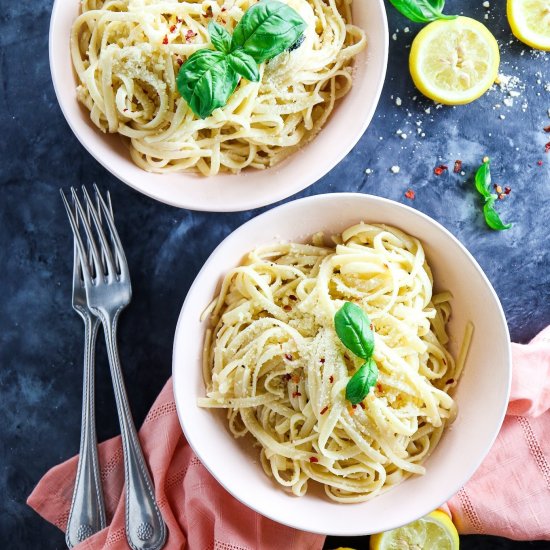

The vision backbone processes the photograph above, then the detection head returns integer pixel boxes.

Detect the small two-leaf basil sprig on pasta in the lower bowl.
[334,302,378,405]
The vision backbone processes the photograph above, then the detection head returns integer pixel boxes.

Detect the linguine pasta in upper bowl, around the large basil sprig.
[71,0,366,175]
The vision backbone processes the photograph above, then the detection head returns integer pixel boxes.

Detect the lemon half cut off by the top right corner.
[507,0,550,51]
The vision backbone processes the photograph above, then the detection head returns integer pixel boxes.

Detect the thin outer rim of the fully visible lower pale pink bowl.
[172,193,512,536]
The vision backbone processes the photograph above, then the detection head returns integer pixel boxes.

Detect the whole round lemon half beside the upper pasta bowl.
[409,17,500,105]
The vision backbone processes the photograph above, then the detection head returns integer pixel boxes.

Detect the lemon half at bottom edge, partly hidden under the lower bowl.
[370,510,460,550]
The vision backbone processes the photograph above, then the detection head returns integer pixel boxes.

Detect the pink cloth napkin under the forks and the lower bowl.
[27,327,550,550]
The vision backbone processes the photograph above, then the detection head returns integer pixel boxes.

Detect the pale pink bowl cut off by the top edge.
[50,0,388,212]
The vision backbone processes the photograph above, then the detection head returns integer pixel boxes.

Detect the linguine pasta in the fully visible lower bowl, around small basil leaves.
[199,223,472,502]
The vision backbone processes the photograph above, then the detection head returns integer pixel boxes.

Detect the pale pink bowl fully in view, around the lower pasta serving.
[172,193,511,535]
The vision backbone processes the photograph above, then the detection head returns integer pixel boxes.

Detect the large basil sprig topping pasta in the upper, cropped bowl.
[176,0,306,118]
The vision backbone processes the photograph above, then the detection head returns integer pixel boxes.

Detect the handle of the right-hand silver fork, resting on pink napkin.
[102,312,166,550]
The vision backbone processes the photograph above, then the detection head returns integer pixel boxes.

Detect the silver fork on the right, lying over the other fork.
[61,185,166,550]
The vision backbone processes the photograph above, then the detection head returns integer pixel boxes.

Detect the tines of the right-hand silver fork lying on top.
[60,188,129,285]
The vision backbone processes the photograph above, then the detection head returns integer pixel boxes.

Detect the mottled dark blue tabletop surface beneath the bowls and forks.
[0,0,550,550]
